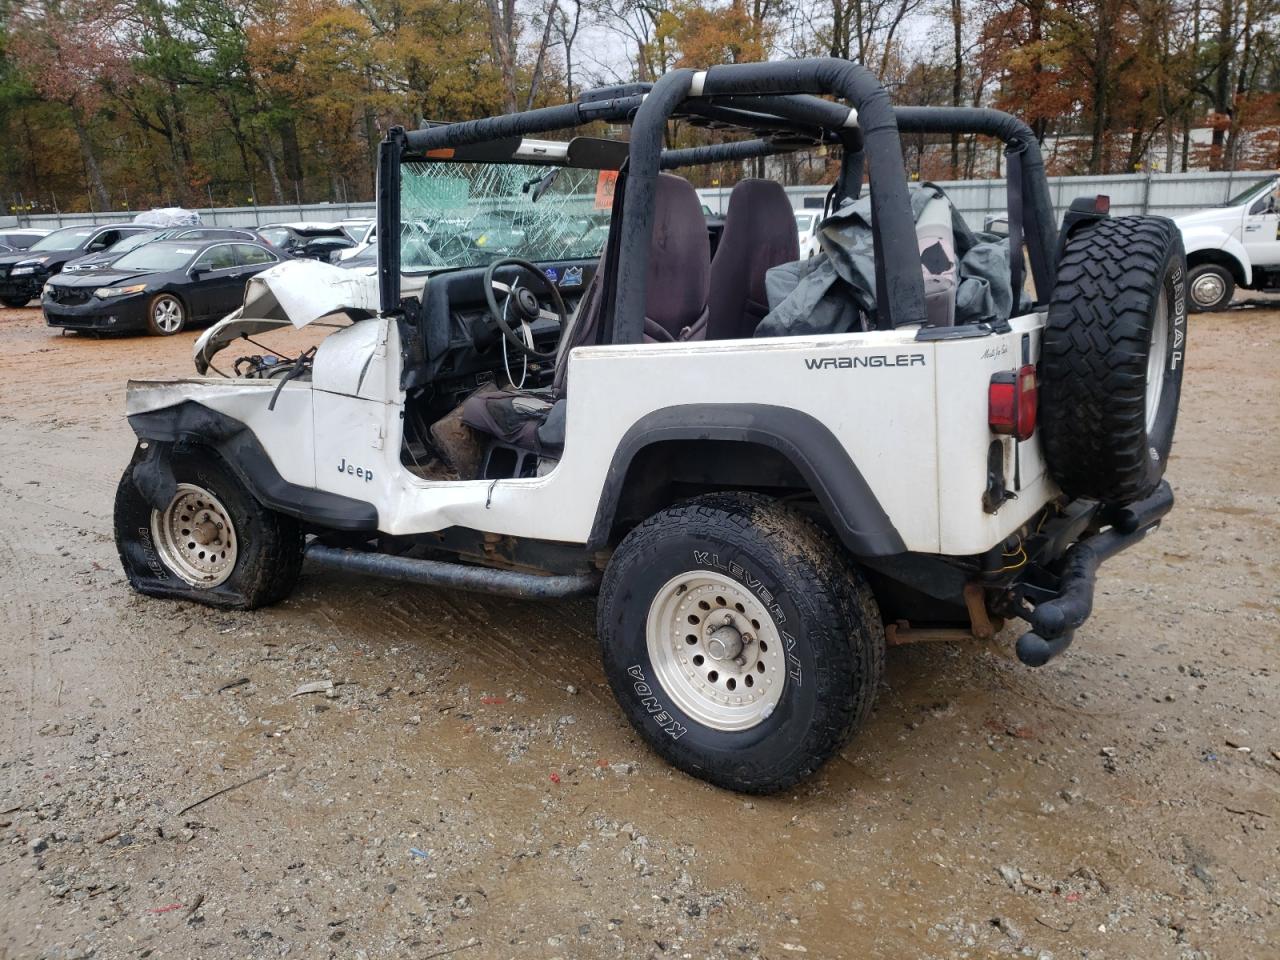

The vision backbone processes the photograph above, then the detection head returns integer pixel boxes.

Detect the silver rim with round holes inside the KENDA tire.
[645,570,787,731]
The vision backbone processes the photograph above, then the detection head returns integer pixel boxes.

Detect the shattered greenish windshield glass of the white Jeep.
[401,161,617,273]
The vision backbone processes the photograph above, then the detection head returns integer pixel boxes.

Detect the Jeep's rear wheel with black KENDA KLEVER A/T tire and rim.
[596,493,884,794]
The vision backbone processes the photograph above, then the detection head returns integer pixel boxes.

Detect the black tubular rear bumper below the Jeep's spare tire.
[1016,480,1174,667]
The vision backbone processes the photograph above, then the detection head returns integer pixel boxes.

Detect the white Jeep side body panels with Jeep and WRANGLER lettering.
[128,316,1057,554]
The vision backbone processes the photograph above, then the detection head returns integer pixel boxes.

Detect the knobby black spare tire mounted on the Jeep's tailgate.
[1038,216,1187,503]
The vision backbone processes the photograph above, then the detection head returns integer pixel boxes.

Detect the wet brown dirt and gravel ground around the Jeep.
[0,302,1280,960]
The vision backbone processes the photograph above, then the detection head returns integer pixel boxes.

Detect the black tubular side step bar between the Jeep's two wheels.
[306,540,600,600]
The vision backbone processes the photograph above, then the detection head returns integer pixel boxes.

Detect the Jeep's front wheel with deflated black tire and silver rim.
[115,448,302,609]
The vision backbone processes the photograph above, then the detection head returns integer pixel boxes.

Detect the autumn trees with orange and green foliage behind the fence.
[0,0,1280,211]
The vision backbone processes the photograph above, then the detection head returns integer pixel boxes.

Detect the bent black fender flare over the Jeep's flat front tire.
[129,401,378,532]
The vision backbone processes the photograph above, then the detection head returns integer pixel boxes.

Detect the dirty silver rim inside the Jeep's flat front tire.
[151,484,239,588]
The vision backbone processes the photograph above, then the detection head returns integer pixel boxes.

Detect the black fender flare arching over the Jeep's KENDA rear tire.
[588,403,906,557]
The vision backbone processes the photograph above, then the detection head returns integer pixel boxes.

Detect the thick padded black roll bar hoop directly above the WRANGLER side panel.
[608,58,925,343]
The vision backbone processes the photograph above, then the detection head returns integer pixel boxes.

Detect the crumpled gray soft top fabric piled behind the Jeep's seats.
[755,183,1014,337]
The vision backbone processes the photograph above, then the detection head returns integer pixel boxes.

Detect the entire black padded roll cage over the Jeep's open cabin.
[378,64,1057,327]
